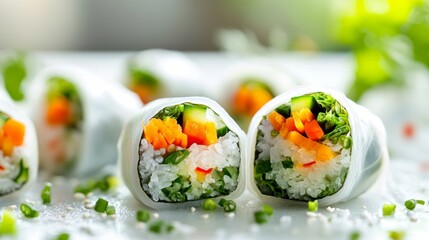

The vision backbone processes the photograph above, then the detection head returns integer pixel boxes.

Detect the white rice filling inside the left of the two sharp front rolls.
[138,131,240,201]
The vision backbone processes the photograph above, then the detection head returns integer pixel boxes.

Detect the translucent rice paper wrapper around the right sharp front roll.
[247,86,389,206]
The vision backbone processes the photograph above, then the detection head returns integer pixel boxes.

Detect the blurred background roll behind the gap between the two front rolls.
[219,60,296,129]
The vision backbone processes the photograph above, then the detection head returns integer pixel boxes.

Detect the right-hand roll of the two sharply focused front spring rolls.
[244,87,388,205]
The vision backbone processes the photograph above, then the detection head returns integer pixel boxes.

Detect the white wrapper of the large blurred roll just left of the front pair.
[31,66,142,176]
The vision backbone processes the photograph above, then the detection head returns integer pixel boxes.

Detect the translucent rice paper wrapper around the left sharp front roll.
[118,97,246,209]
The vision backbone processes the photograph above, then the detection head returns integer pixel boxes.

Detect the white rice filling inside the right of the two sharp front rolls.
[256,119,350,200]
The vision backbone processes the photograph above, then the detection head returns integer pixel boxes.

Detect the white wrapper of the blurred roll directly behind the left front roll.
[125,49,204,97]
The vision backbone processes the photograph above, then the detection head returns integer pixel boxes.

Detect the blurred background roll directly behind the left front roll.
[125,49,202,103]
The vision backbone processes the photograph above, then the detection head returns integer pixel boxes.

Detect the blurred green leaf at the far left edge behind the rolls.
[0,51,27,101]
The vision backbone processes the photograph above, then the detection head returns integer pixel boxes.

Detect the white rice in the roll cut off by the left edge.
[0,147,22,196]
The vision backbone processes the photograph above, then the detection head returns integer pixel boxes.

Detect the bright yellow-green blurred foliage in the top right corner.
[338,0,429,100]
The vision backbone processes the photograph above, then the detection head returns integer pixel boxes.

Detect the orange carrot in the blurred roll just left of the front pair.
[46,97,72,125]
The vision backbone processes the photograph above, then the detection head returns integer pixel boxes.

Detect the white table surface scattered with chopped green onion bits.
[0,52,429,239]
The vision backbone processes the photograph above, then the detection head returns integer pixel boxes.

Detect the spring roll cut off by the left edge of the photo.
[0,90,39,197]
